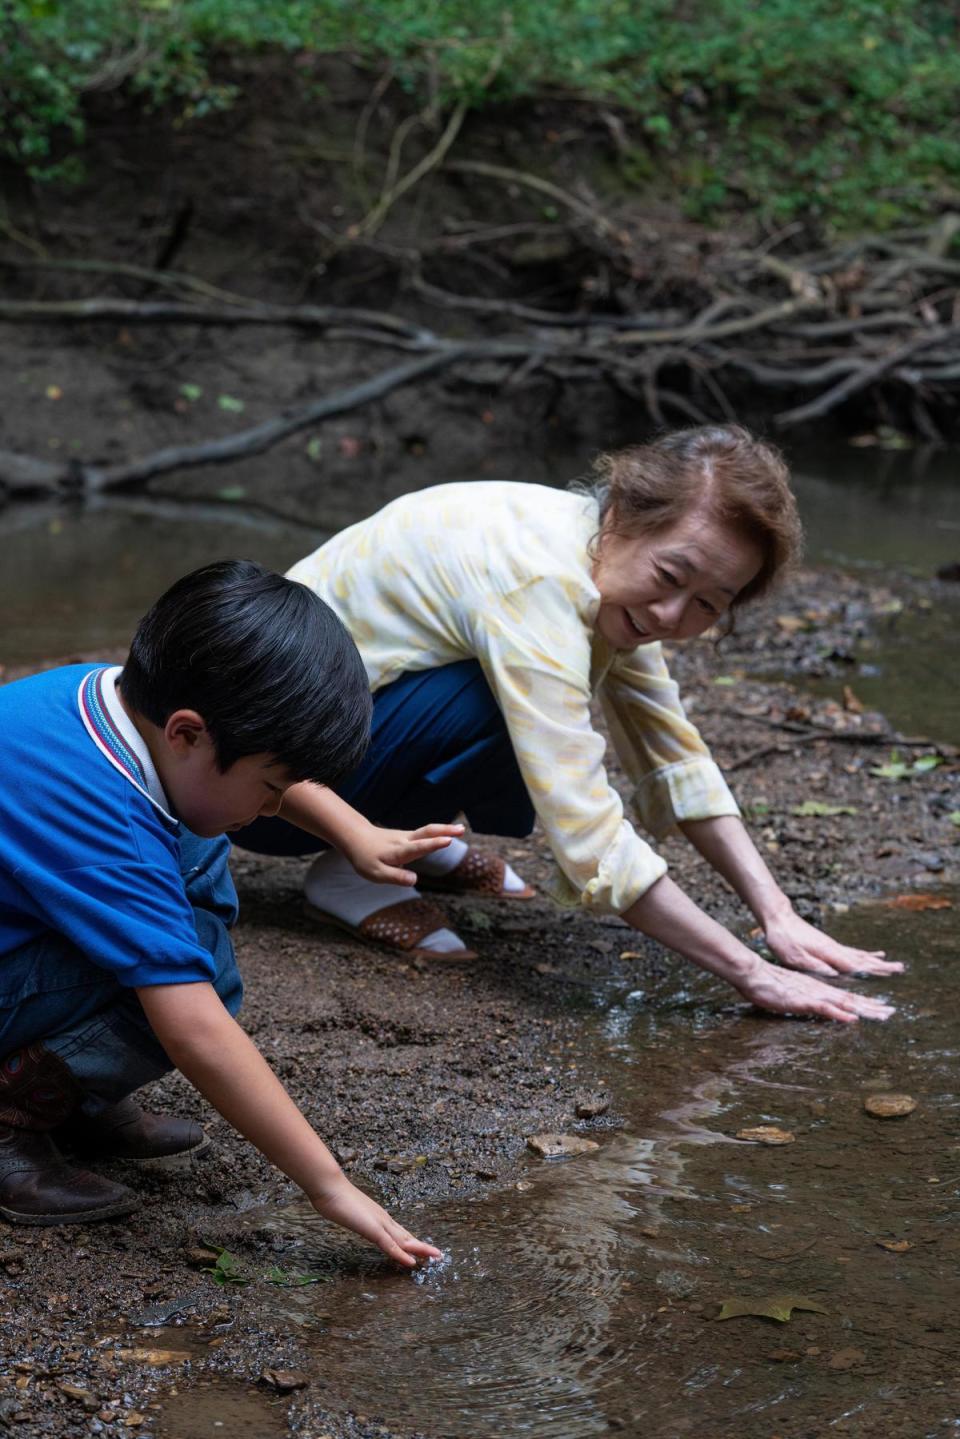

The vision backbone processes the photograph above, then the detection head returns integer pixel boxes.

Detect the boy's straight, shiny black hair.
[119,560,371,784]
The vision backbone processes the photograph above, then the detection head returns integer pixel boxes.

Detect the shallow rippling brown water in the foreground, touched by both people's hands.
[228,907,960,1439]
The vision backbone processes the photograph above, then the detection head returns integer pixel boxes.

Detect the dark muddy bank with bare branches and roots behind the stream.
[0,59,957,522]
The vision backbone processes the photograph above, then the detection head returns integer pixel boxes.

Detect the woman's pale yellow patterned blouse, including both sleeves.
[289,481,738,914]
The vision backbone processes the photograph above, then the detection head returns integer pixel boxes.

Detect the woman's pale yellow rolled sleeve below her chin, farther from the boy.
[600,645,740,839]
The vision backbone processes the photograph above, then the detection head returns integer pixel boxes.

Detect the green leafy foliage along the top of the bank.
[0,0,960,229]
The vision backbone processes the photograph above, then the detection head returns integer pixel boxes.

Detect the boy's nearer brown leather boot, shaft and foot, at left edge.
[0,1043,137,1225]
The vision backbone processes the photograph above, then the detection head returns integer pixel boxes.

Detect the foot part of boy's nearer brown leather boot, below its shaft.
[0,1125,138,1225]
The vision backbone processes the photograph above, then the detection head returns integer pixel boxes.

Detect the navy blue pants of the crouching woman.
[233,659,534,855]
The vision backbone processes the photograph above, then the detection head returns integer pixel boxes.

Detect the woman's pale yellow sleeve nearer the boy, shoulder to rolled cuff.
[472,577,666,914]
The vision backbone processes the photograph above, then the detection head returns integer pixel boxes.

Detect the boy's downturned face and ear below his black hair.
[154,711,294,839]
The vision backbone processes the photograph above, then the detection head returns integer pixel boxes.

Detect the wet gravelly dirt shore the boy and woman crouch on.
[0,555,960,1439]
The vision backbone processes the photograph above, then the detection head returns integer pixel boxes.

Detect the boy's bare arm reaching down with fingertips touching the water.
[137,984,440,1268]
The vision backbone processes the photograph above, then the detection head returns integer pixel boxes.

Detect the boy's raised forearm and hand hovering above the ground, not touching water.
[278,780,463,885]
